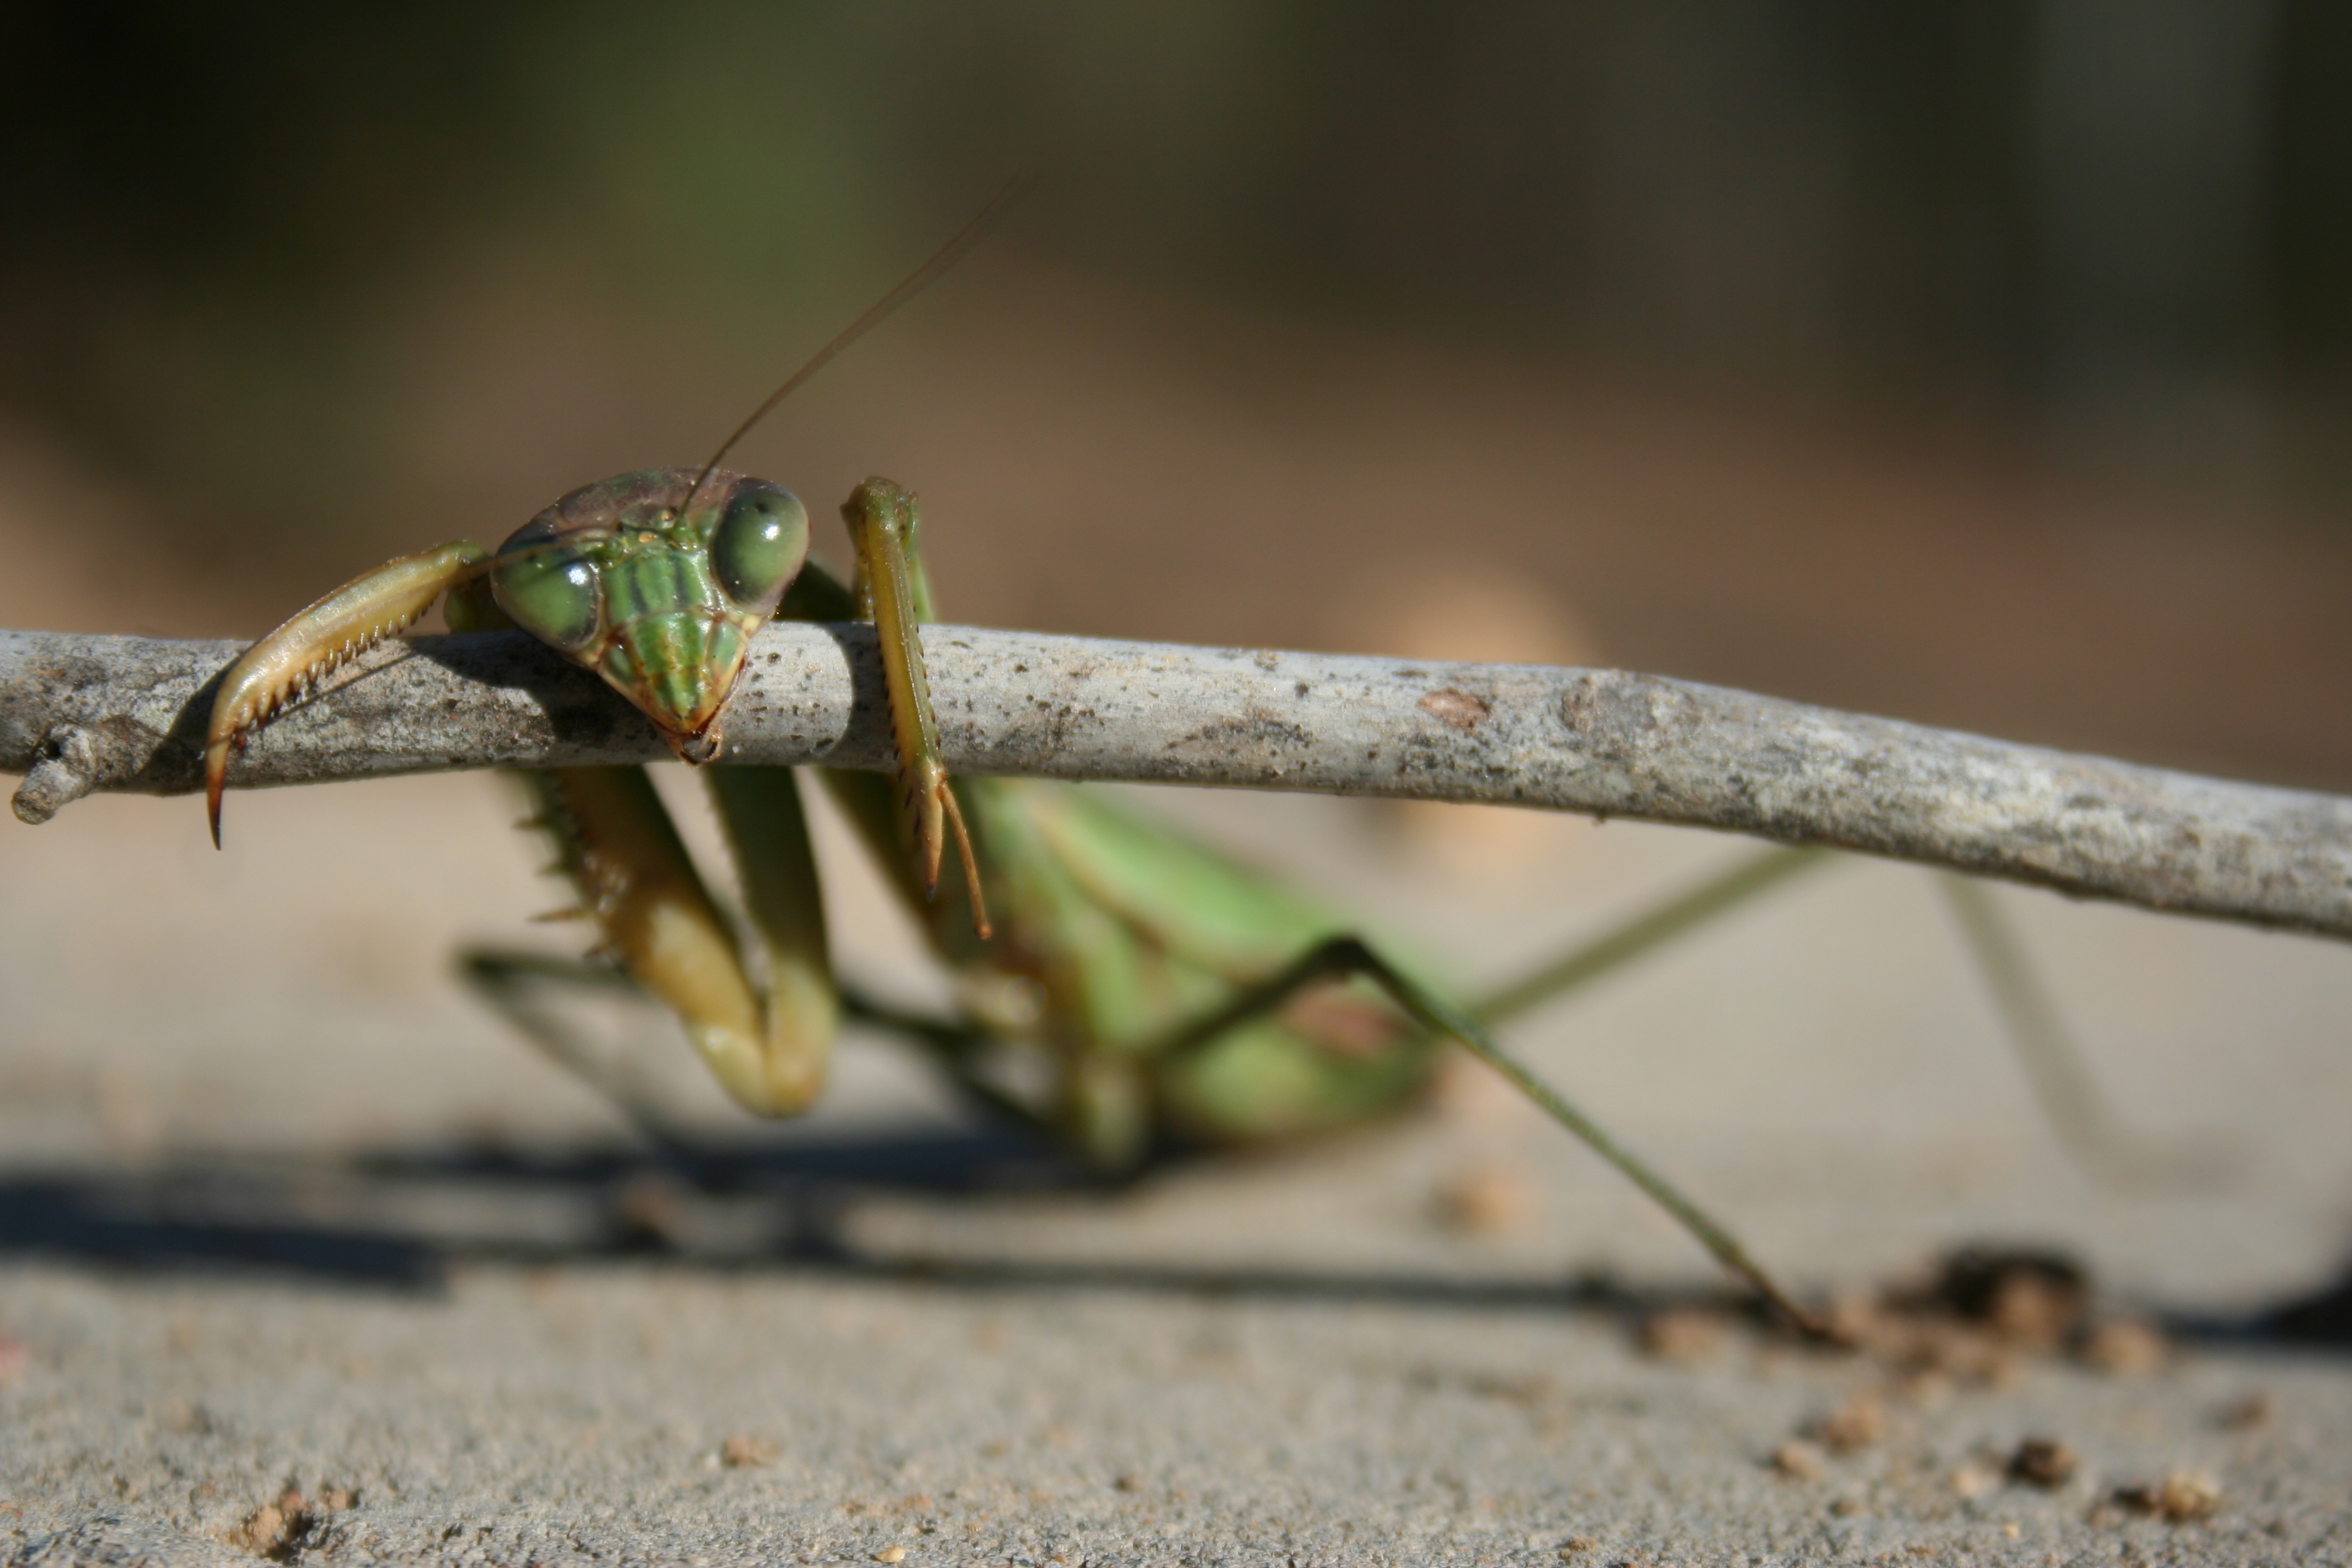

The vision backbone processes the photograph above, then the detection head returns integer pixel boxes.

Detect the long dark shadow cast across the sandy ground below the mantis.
[0,1128,2352,1352]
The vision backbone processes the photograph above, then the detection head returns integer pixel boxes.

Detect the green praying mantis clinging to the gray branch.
[205,214,2126,1333]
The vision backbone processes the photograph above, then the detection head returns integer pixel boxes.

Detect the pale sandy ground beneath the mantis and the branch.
[0,276,2352,1563]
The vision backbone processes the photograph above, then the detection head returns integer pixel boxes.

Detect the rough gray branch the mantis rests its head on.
[0,623,2352,938]
